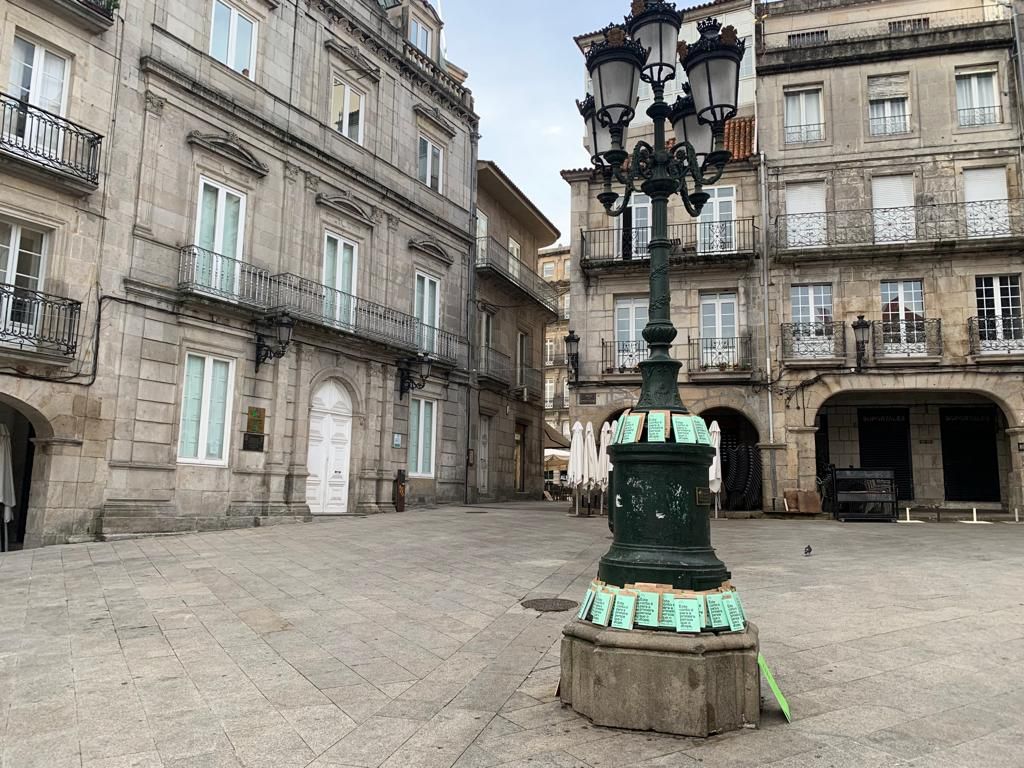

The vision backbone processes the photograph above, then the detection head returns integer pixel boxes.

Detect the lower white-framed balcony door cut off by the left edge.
[0,220,46,345]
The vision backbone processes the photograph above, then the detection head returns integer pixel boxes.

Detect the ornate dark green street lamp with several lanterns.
[578,0,743,590]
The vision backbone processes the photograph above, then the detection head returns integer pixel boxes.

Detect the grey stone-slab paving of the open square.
[0,504,1024,768]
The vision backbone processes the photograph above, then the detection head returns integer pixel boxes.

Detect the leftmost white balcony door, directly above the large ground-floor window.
[194,177,246,297]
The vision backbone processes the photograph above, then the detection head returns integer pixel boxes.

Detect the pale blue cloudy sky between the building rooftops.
[433,0,630,245]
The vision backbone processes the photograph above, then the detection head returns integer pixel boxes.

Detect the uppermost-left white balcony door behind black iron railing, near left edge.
[3,35,69,160]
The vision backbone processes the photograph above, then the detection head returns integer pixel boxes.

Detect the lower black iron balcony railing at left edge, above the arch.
[0,284,82,357]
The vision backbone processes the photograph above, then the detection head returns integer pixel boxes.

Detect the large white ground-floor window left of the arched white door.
[178,353,233,465]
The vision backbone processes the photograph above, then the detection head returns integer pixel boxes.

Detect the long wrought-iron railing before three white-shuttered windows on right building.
[773,200,1024,250]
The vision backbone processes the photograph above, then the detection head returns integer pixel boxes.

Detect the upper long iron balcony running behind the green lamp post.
[581,218,758,271]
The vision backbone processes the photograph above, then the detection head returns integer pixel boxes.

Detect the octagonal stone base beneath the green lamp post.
[560,620,761,737]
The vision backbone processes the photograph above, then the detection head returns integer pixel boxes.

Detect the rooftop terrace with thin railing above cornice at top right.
[758,0,1013,74]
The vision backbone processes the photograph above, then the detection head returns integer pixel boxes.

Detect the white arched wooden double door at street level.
[306,379,352,515]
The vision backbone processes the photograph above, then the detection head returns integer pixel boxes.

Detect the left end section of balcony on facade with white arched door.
[178,245,271,309]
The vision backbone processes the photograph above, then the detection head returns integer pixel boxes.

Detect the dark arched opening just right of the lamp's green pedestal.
[700,408,763,512]
